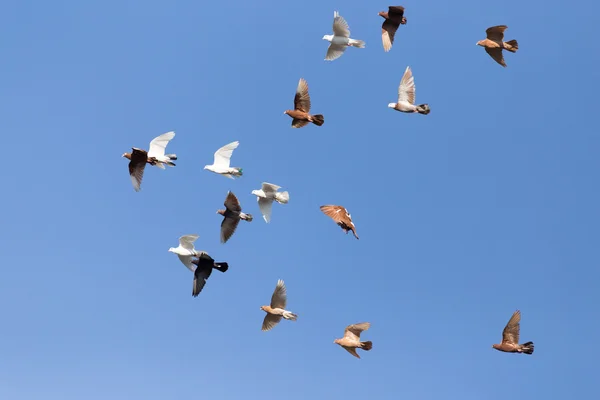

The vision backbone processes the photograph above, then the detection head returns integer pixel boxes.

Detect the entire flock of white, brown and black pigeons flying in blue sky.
[123,6,534,358]
